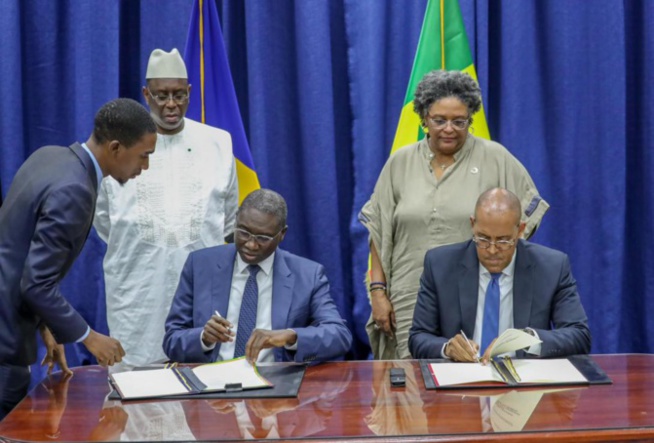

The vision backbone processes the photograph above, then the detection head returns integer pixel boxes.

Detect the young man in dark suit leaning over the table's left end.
[0,99,157,419]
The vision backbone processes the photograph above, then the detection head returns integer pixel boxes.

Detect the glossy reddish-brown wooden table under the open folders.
[0,354,654,442]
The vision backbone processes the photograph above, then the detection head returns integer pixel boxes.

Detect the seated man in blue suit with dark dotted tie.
[163,189,352,362]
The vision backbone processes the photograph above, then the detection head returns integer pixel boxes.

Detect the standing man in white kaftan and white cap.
[94,49,238,371]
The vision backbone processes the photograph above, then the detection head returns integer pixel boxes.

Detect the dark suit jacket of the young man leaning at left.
[0,143,98,365]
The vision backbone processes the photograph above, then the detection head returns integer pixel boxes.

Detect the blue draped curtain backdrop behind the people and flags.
[0,0,654,386]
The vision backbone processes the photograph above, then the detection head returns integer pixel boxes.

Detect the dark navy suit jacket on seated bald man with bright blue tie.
[409,240,590,358]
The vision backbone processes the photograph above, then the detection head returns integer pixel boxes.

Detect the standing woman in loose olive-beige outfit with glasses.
[359,71,549,360]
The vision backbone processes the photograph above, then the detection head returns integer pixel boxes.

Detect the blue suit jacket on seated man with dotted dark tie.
[163,244,352,363]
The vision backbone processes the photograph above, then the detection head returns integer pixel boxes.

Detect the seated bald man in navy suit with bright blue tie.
[409,188,591,362]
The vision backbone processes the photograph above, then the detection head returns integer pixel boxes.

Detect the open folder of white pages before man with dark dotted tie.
[110,357,273,400]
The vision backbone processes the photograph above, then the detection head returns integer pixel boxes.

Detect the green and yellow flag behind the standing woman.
[391,0,490,154]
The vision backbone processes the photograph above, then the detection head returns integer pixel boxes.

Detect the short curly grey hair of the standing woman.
[413,70,481,123]
